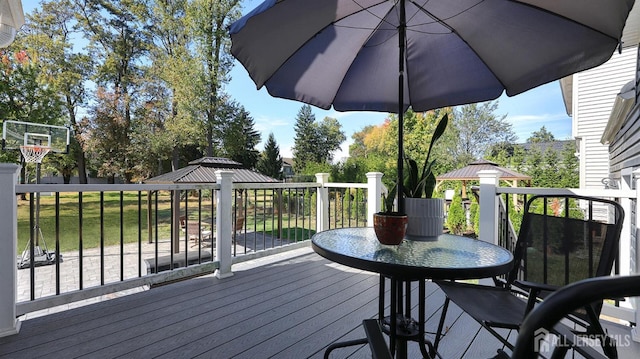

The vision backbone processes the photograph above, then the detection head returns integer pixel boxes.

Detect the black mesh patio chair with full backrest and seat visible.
[434,195,624,357]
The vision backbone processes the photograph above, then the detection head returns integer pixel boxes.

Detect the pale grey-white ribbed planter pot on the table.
[404,198,444,241]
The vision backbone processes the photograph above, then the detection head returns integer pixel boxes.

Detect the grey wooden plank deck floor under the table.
[0,248,640,359]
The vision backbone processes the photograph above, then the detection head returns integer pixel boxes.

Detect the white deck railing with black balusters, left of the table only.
[0,164,382,336]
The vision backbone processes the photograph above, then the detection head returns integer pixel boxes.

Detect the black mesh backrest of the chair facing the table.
[507,195,624,286]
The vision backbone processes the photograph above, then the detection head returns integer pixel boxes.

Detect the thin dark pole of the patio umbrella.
[398,0,407,213]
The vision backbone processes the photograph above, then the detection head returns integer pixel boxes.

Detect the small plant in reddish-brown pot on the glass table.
[373,184,407,245]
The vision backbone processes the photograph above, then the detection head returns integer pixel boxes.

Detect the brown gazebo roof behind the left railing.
[145,157,280,183]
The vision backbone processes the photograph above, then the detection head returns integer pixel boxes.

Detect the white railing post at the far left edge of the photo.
[0,163,20,337]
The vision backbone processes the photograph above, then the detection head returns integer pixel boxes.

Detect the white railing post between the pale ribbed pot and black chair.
[478,170,500,244]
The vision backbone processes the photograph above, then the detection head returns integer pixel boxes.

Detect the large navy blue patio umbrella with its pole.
[229,0,635,212]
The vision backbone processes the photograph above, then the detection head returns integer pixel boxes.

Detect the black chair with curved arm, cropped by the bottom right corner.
[504,275,640,359]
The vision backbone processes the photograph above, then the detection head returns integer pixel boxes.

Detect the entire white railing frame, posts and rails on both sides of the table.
[0,164,640,336]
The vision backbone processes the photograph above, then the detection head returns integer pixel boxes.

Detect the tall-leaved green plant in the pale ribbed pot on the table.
[403,114,449,240]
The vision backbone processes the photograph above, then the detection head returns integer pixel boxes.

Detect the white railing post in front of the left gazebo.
[214,170,233,279]
